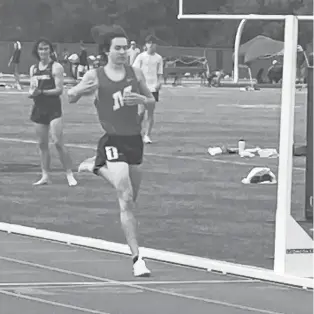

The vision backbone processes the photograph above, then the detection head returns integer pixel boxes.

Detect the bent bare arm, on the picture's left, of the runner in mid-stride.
[68,69,98,103]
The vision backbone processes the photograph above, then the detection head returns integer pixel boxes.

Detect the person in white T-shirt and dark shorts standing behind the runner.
[133,36,163,144]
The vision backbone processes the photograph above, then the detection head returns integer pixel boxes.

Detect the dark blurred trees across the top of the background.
[0,0,313,48]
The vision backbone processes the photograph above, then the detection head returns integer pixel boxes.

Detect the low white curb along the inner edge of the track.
[0,223,314,289]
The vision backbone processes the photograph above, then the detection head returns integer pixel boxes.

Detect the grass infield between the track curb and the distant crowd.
[0,87,310,268]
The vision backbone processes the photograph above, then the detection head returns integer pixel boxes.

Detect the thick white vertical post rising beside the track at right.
[274,15,298,274]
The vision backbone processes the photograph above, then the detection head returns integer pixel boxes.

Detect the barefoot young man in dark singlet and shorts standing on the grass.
[29,39,77,186]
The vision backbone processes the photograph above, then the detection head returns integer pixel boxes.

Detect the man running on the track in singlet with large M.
[68,28,155,277]
